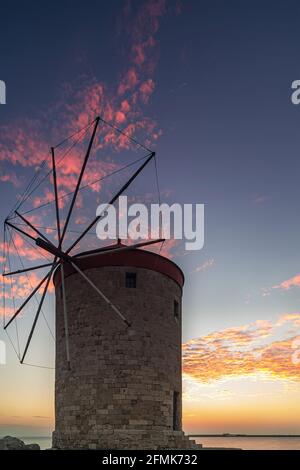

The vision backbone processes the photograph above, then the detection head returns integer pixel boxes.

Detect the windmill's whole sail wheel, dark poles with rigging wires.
[3,116,164,368]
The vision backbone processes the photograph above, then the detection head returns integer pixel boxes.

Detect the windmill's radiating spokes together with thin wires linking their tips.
[3,116,158,370]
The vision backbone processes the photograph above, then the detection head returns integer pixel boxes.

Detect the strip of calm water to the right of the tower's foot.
[195,436,300,450]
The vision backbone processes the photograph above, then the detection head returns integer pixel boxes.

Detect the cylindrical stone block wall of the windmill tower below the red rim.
[53,266,199,449]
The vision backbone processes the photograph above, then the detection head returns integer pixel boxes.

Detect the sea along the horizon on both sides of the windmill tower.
[20,436,300,450]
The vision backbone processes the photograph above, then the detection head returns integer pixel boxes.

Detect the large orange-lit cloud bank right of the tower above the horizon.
[183,313,300,383]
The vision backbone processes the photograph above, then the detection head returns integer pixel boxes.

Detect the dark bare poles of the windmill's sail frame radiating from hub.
[2,116,164,368]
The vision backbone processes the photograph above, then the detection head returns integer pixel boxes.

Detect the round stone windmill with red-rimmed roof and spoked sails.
[4,118,200,449]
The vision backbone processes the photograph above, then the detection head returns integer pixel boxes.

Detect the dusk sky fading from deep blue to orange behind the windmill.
[0,0,300,435]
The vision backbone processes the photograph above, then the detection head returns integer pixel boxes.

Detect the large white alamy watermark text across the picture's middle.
[96,196,204,251]
